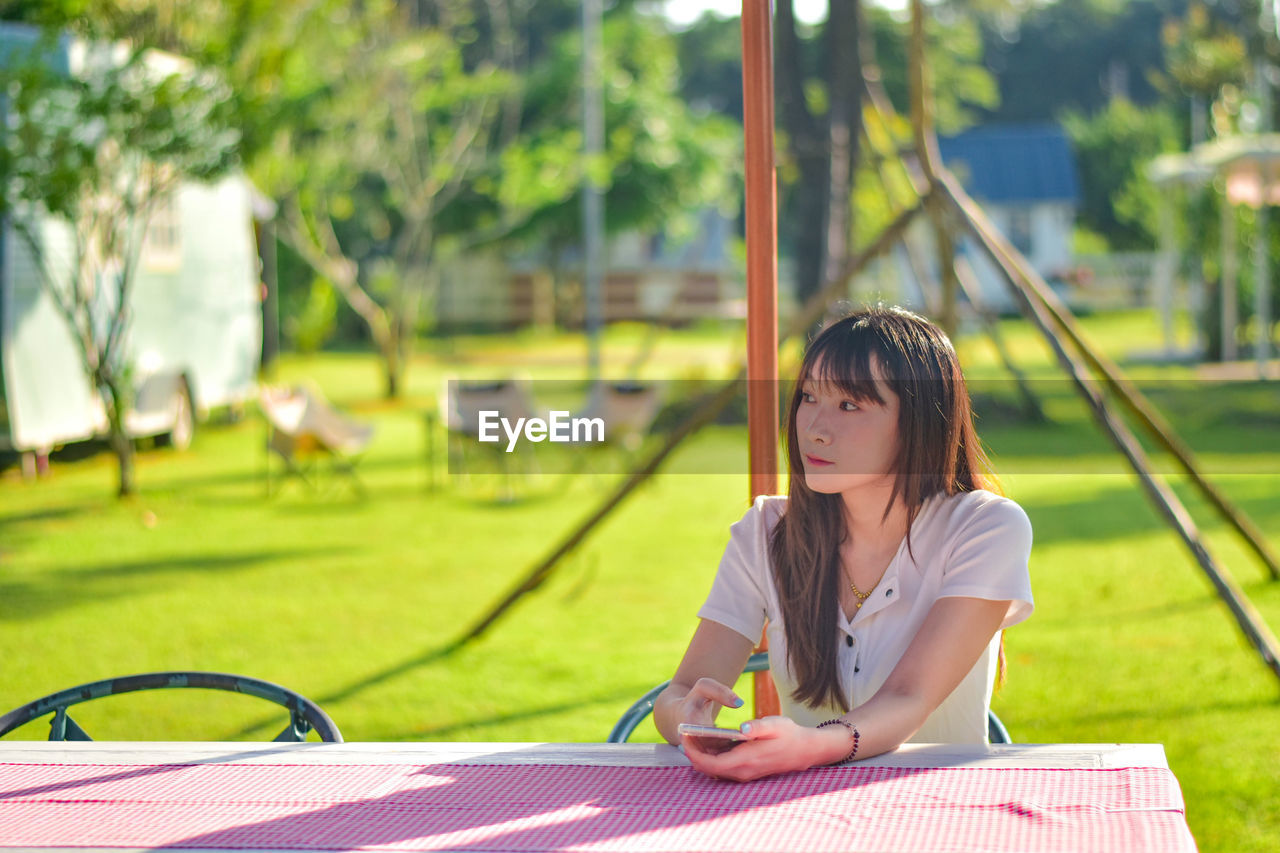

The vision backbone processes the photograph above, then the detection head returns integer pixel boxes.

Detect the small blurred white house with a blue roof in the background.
[938,124,1080,311]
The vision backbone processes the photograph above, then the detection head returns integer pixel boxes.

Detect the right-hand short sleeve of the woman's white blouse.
[938,498,1036,628]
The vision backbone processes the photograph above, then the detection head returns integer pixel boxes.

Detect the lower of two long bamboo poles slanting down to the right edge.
[937,175,1280,679]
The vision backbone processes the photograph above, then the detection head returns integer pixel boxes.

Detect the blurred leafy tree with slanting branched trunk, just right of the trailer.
[243,0,515,397]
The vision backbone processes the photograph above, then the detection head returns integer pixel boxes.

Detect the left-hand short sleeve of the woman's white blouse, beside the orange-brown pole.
[698,498,769,643]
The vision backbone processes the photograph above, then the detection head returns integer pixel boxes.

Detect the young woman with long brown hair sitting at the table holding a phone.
[654,307,1032,780]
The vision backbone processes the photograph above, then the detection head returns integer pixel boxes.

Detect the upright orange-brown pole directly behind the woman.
[742,0,780,717]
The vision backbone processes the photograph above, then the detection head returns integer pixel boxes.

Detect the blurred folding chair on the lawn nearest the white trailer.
[259,386,374,493]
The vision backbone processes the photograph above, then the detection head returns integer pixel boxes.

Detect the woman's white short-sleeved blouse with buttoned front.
[698,491,1034,743]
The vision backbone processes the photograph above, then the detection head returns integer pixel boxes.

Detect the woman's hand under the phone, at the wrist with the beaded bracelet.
[684,717,822,781]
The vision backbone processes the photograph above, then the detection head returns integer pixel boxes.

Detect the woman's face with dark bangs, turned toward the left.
[796,359,899,494]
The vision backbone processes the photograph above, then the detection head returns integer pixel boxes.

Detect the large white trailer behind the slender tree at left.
[0,26,262,466]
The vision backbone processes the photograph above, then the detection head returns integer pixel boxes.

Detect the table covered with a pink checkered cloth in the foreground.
[0,742,1196,853]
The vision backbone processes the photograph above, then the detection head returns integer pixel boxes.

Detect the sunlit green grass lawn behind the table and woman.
[0,308,1280,850]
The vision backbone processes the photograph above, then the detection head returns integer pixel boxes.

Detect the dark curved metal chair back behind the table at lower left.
[0,671,342,743]
